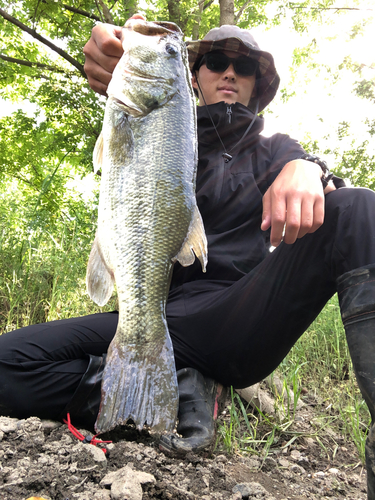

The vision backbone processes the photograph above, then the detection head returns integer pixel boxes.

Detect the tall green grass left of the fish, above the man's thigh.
[0,176,116,333]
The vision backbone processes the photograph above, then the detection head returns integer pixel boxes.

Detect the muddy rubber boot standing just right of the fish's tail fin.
[159,368,227,456]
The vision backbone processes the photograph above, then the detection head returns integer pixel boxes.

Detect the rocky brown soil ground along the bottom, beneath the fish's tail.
[0,398,367,500]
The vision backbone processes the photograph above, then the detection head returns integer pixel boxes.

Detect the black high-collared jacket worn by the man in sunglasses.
[171,102,332,290]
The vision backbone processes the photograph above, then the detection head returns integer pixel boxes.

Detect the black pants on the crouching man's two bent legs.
[0,188,375,418]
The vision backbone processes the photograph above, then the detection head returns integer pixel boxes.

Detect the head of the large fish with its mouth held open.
[107,19,188,117]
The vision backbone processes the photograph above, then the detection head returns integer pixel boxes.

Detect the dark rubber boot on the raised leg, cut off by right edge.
[337,265,375,500]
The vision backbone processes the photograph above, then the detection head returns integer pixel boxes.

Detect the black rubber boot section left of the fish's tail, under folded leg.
[60,354,107,432]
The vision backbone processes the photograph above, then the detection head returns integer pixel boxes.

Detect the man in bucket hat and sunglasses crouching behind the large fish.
[0,17,375,500]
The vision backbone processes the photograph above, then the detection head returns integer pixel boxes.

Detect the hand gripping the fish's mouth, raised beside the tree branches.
[83,23,124,95]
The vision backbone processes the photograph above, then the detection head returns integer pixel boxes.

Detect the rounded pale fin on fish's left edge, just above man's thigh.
[86,235,115,306]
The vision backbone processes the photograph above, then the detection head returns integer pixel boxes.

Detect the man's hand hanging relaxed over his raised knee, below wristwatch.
[261,160,336,247]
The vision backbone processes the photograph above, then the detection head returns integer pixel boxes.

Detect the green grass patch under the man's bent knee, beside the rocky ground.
[217,296,370,463]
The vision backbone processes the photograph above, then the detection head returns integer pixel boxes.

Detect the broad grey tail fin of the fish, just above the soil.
[95,334,178,434]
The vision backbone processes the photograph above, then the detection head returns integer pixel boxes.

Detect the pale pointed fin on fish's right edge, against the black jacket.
[173,206,207,272]
